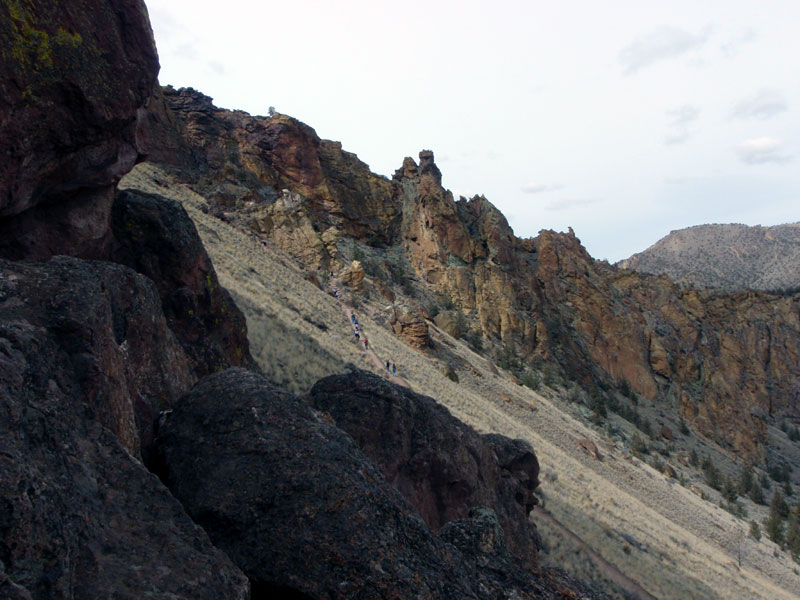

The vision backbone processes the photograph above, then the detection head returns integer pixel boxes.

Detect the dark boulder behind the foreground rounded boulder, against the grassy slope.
[309,371,539,569]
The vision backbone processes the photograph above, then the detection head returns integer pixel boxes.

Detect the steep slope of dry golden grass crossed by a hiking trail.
[122,163,800,600]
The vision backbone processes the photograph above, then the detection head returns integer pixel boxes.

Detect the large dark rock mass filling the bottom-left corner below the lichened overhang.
[0,258,248,600]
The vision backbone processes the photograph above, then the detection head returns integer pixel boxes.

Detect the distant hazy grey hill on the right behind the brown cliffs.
[617,223,800,291]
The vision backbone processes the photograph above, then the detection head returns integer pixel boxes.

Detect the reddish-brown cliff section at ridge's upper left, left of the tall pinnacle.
[142,88,399,262]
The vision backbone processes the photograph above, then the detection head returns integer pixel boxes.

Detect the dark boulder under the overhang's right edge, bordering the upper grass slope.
[112,191,255,377]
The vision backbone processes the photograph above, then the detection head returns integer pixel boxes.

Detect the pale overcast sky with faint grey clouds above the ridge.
[146,0,800,261]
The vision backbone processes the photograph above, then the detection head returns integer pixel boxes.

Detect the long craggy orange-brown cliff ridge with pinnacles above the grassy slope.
[149,88,800,458]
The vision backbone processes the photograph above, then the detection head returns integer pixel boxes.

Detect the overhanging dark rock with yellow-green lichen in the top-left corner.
[0,0,158,258]
